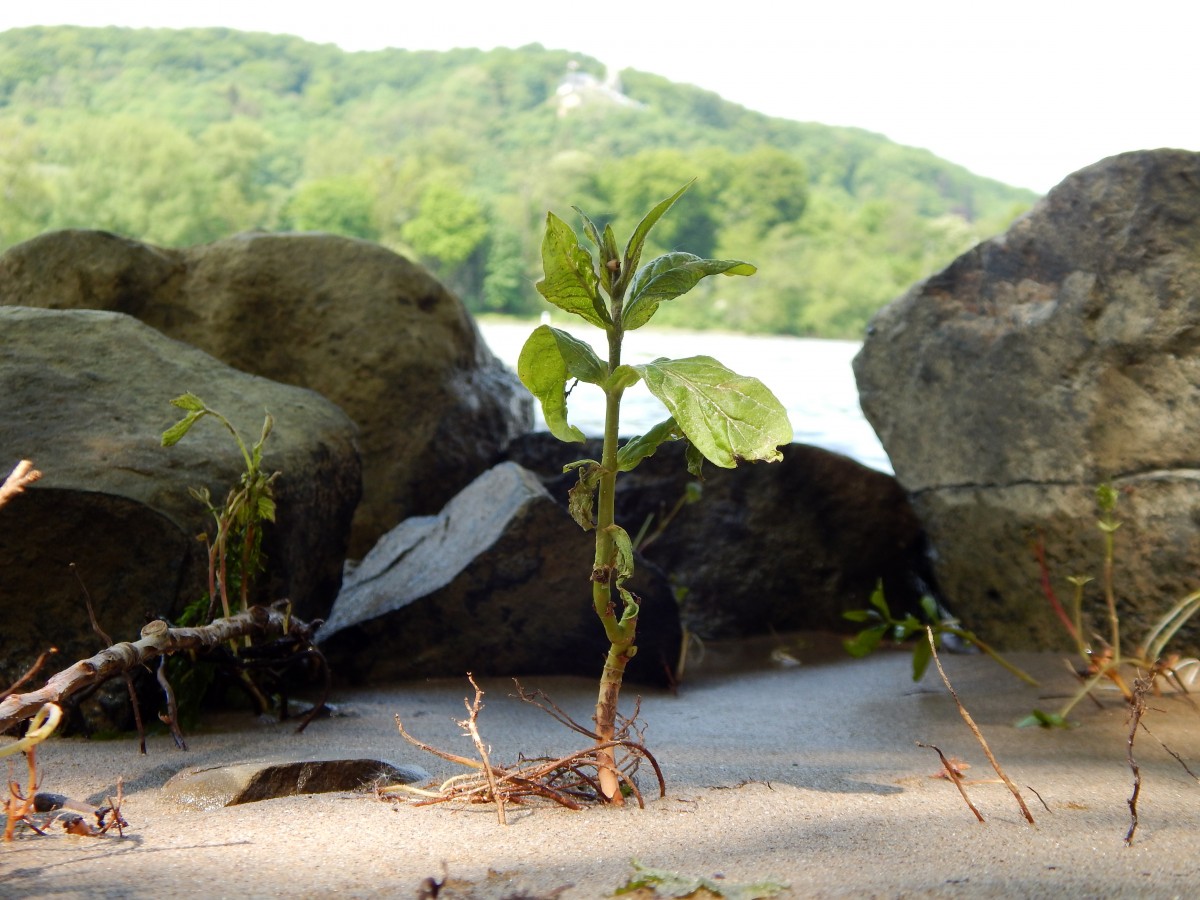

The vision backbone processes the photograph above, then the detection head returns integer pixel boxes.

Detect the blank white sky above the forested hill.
[0,0,1200,191]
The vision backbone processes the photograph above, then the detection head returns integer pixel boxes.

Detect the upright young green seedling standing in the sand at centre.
[517,182,792,804]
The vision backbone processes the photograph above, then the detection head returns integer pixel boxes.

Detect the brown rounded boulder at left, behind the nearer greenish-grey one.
[0,230,532,557]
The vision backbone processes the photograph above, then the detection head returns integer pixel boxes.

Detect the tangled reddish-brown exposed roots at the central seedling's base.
[376,676,666,824]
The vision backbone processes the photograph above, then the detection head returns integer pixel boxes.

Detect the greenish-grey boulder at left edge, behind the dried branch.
[0,307,361,685]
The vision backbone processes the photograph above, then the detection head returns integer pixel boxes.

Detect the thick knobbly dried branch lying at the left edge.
[0,600,311,733]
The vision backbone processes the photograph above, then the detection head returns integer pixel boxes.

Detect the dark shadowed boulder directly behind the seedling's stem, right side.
[508,433,929,637]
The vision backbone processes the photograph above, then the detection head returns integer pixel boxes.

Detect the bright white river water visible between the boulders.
[479,317,892,473]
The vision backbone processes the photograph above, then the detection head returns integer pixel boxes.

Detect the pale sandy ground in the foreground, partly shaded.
[0,644,1200,899]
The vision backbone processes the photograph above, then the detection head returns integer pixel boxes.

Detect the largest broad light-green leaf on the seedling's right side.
[635,356,792,470]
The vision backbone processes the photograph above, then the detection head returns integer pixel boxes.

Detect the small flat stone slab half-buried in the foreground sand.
[162,760,430,810]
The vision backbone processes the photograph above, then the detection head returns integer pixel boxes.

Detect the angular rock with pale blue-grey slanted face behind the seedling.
[318,462,680,684]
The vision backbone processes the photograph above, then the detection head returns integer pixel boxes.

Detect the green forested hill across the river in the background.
[0,28,1036,337]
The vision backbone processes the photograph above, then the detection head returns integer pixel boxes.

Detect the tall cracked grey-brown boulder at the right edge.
[854,150,1200,648]
